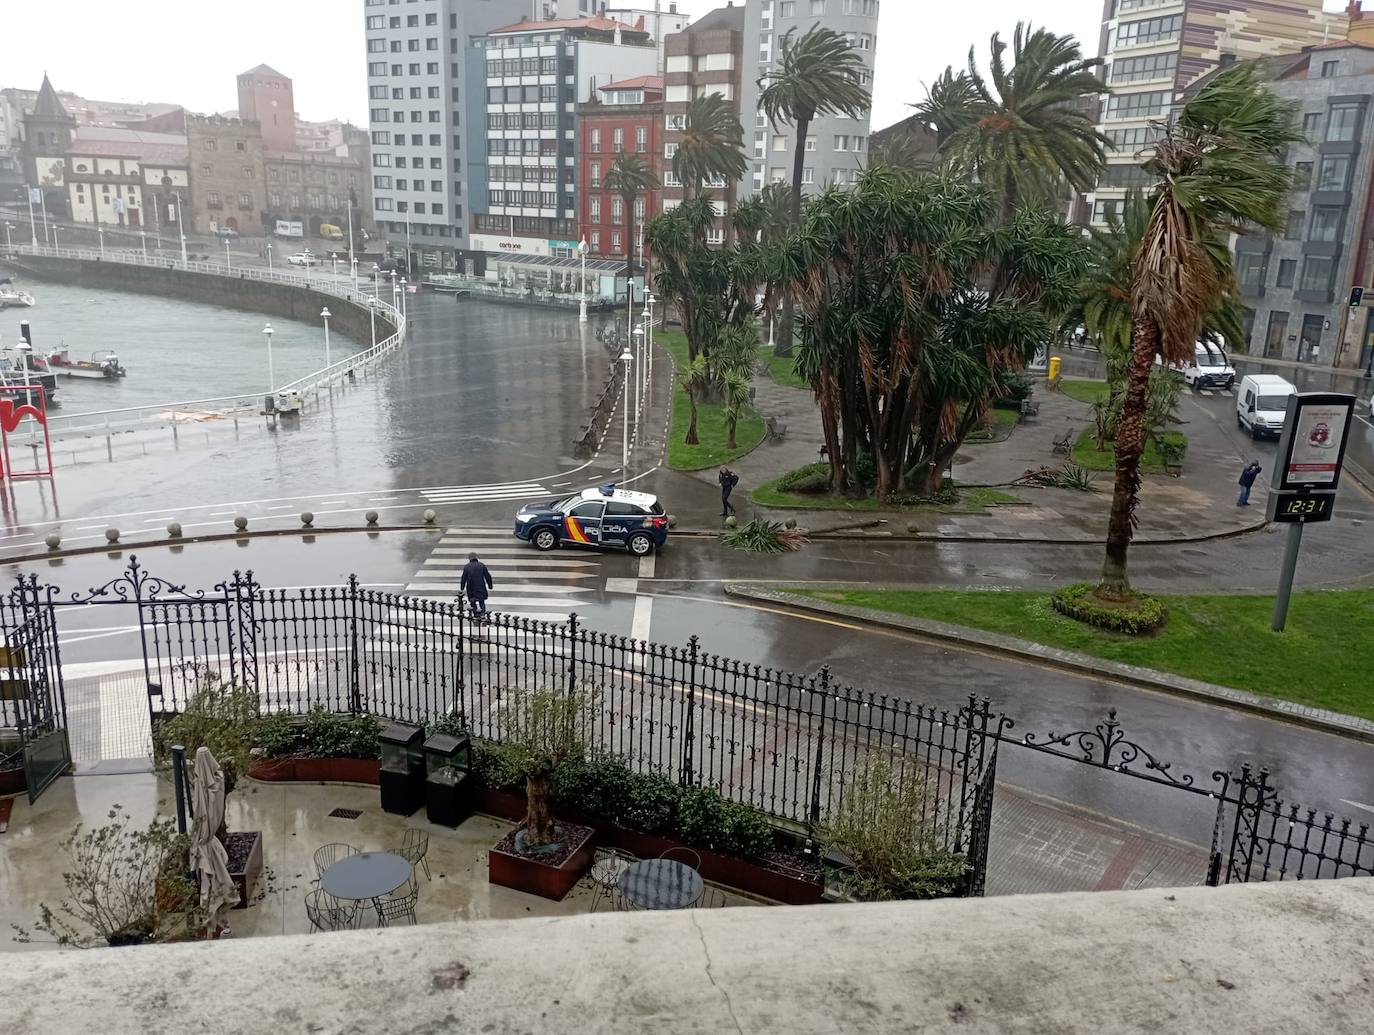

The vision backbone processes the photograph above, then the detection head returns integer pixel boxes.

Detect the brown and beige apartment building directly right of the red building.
[664,5,746,245]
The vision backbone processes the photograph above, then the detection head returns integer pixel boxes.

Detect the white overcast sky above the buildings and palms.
[0,0,1344,129]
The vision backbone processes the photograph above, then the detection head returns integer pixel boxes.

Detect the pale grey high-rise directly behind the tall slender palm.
[739,0,879,195]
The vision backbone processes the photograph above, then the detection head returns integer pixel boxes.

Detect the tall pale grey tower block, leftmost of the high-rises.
[363,0,534,271]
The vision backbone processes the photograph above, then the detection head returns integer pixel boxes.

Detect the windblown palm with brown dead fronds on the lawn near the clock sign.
[1098,65,1301,599]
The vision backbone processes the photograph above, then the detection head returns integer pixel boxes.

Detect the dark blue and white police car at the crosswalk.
[515,484,668,557]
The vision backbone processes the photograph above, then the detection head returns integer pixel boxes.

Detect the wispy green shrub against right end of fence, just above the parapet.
[823,759,969,902]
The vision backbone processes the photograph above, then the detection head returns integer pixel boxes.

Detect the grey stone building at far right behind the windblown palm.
[1183,40,1374,368]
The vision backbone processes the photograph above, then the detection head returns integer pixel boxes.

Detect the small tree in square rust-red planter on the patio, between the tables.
[488,689,596,899]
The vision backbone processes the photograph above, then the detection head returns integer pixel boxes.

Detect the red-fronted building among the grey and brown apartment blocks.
[577,76,664,261]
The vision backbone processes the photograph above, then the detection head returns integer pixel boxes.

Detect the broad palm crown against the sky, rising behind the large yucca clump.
[916,22,1106,223]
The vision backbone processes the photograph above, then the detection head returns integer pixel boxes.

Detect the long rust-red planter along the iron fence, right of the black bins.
[477,789,826,906]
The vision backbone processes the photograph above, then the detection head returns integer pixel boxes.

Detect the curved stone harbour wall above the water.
[7,254,396,344]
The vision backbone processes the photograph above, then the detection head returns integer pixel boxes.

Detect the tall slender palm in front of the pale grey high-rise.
[758,25,872,356]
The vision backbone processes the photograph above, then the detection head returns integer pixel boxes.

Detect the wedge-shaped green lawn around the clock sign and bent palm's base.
[797,590,1374,719]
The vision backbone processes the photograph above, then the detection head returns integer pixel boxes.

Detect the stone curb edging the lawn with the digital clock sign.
[724,581,1374,744]
